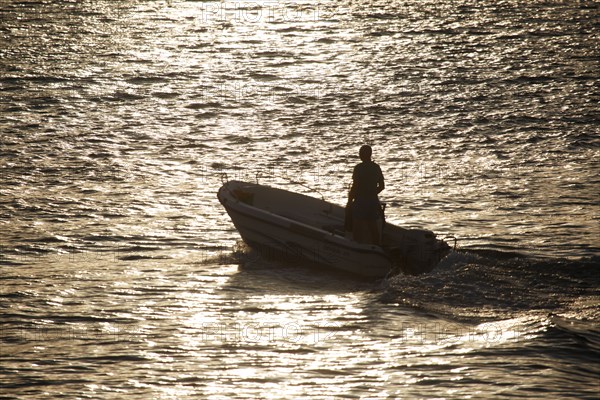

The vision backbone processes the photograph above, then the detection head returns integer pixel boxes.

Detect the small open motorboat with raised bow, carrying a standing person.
[217,181,450,277]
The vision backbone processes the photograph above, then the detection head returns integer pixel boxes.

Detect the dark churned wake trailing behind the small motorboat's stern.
[381,250,600,321]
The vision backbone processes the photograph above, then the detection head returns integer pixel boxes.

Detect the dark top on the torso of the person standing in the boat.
[351,161,383,220]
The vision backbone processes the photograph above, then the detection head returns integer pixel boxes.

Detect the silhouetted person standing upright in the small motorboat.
[348,145,385,245]
